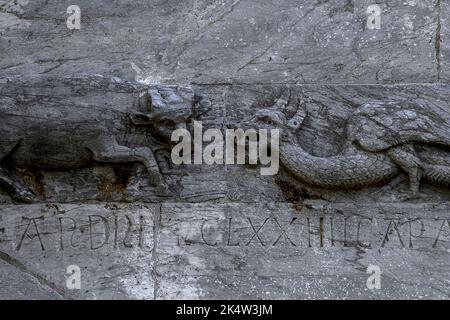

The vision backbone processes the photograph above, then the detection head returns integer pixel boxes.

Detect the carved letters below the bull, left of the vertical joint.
[0,205,153,252]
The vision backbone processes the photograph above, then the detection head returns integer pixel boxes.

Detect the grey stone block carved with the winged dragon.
[227,85,450,202]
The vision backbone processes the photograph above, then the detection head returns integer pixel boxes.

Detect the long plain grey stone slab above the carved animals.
[0,0,445,84]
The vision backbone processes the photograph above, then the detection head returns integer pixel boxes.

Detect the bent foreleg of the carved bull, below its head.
[91,143,169,195]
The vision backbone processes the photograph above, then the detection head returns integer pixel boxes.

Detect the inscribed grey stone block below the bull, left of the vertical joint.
[0,204,159,299]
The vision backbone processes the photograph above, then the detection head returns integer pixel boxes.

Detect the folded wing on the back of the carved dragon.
[347,103,450,151]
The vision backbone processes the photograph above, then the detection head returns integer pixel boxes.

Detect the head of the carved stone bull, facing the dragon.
[130,86,211,143]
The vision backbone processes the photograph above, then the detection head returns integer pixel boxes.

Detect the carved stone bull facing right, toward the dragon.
[0,76,204,202]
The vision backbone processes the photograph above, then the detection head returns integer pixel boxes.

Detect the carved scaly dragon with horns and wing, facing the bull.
[243,92,450,197]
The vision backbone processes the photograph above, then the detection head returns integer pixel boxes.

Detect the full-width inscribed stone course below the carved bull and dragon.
[0,201,450,299]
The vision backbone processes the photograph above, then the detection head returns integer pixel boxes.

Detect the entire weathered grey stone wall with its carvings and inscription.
[0,0,450,299]
